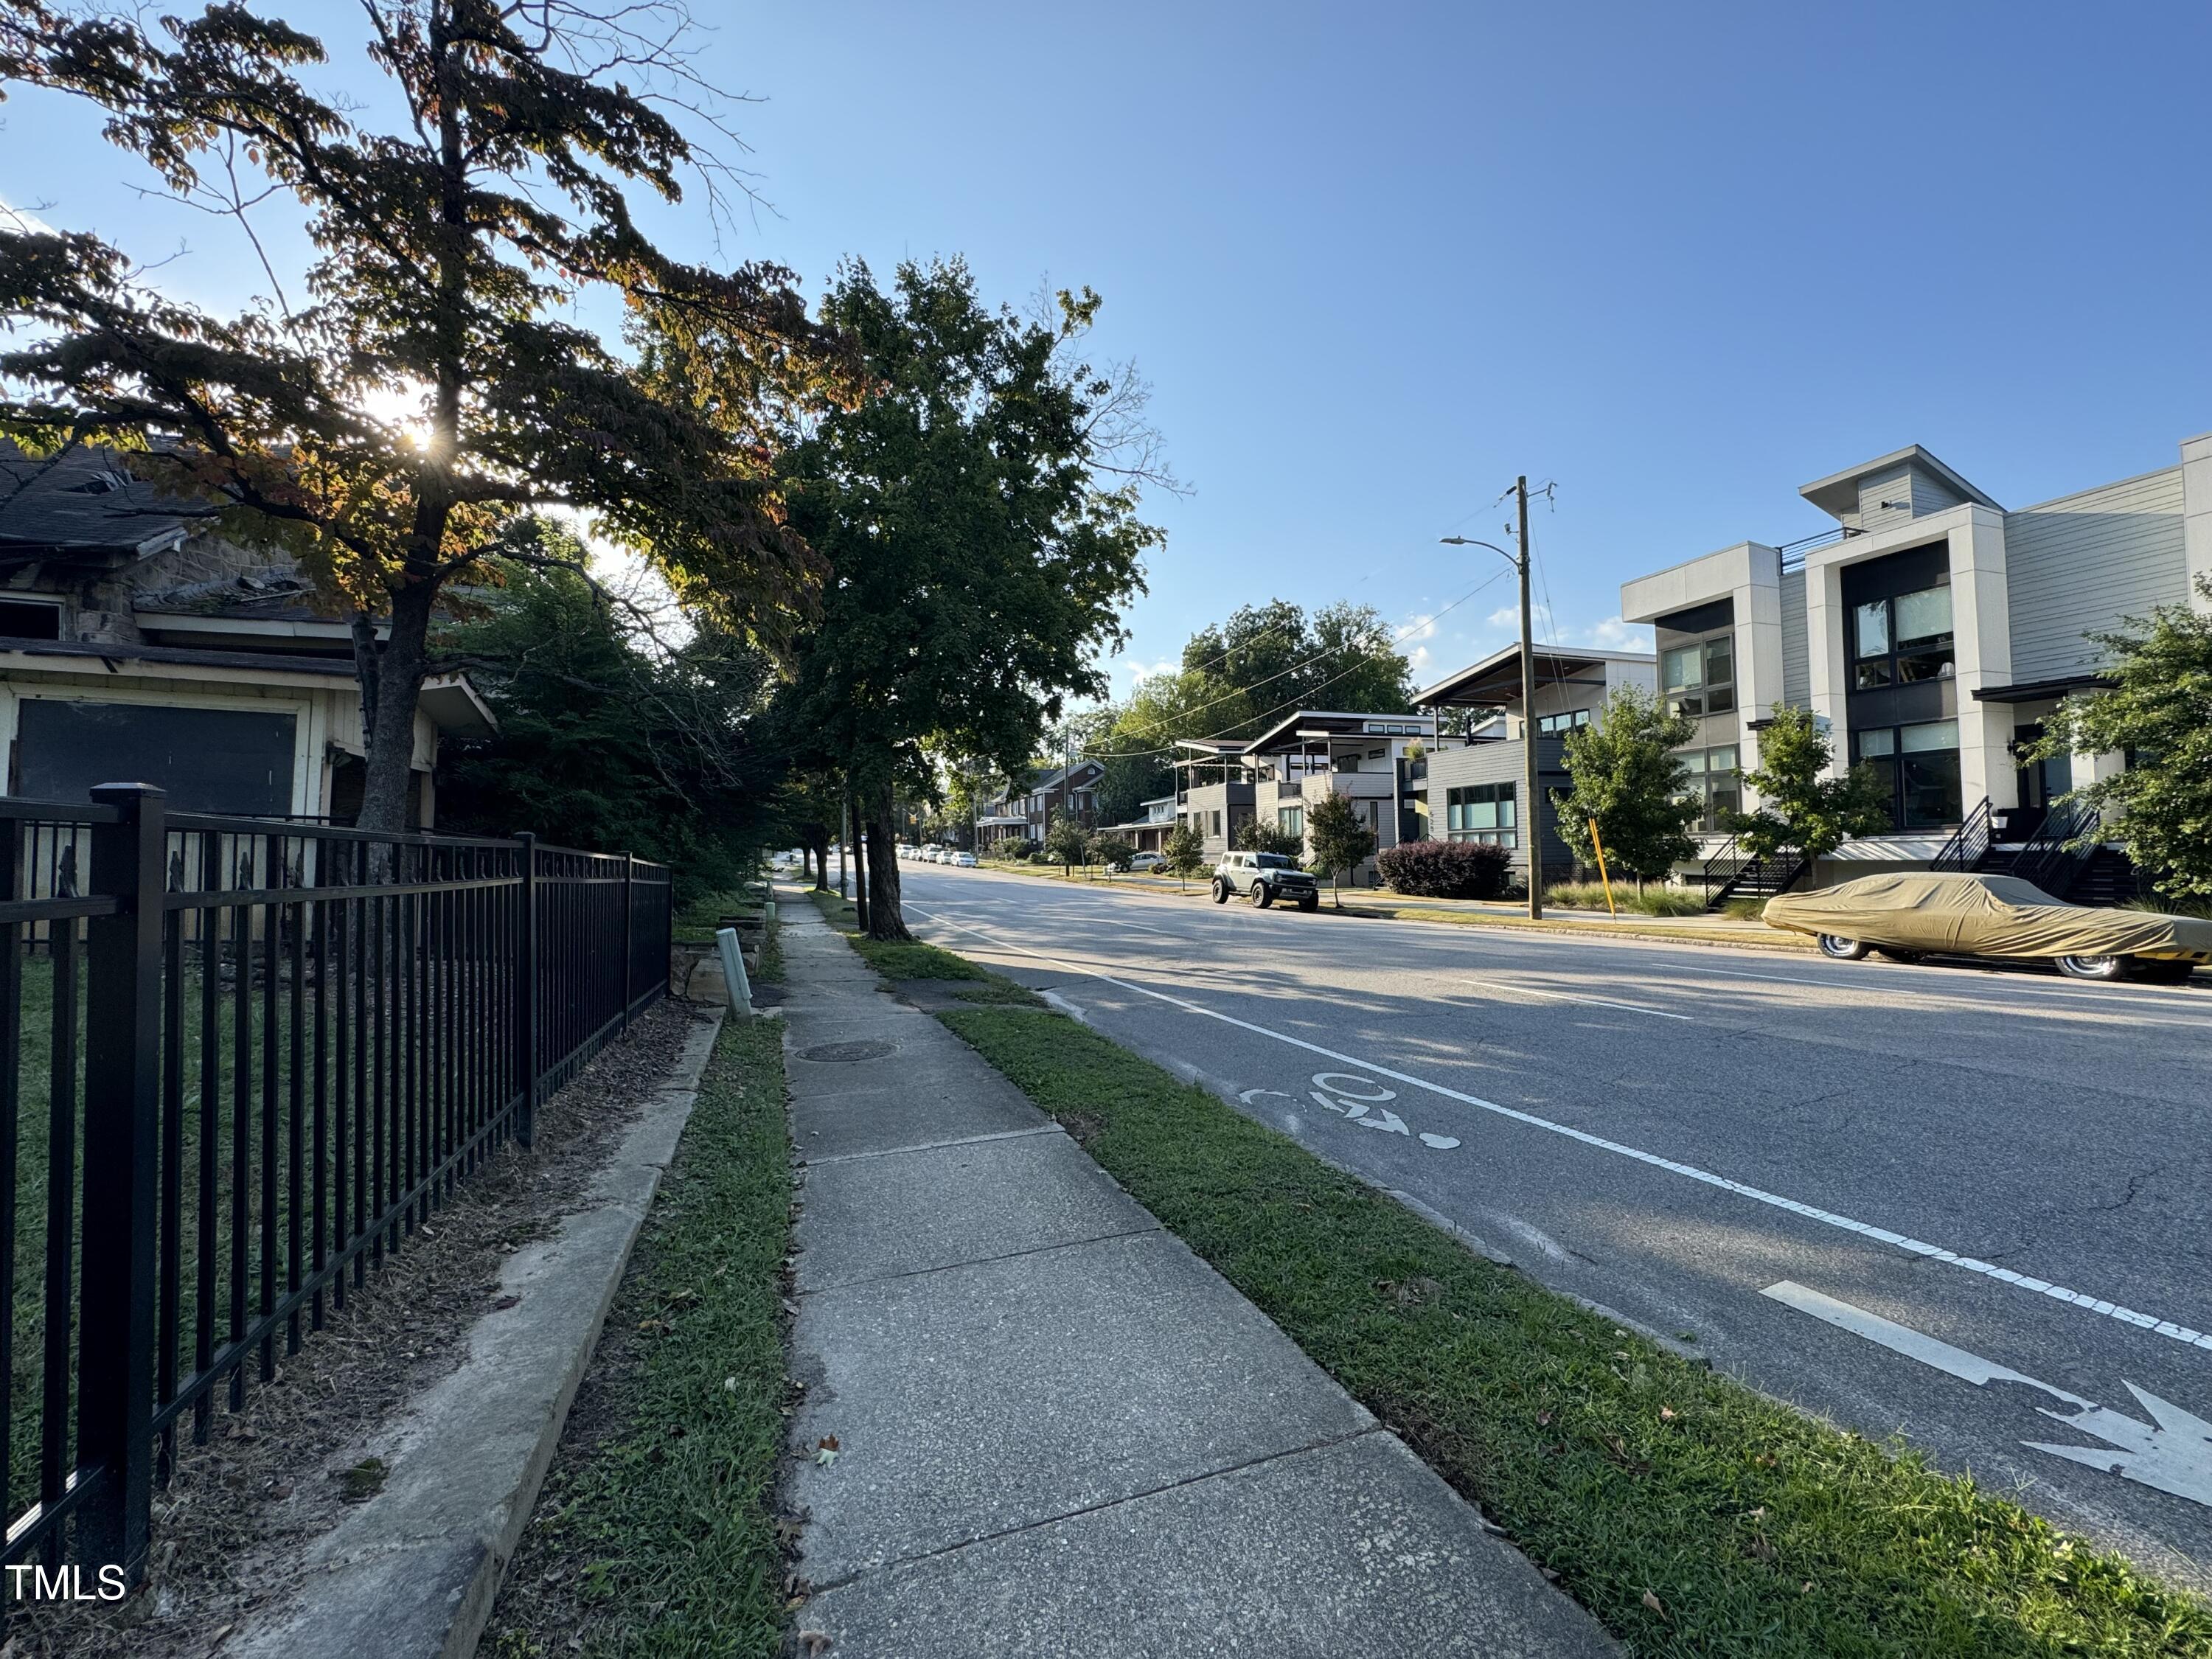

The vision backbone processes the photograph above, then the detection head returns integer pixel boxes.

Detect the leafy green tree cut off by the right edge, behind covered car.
[2035,577,2212,898]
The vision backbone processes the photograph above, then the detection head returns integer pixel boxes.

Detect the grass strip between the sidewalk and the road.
[916,987,2212,1659]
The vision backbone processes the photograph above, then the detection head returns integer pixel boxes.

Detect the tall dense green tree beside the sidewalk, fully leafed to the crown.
[765,261,1159,938]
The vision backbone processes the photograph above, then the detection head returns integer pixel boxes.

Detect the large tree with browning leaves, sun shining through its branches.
[0,0,838,832]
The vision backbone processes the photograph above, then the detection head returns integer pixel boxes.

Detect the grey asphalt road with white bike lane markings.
[900,865,2212,1588]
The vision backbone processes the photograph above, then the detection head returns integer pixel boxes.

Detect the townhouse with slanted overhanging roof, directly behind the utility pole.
[1407,644,1657,883]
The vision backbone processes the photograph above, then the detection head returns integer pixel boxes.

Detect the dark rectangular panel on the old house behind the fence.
[9,697,294,818]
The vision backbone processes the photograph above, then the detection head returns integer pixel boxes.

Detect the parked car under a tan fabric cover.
[1765,872,2212,984]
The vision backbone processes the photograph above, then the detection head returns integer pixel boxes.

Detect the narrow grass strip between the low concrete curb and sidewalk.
[484,1020,792,1659]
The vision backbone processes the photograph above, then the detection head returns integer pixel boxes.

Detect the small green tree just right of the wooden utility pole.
[1548,686,1699,883]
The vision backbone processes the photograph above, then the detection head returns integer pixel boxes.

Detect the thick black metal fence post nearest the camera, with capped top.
[78,783,166,1582]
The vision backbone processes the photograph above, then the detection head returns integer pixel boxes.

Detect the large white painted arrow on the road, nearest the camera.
[1759,1279,2212,1509]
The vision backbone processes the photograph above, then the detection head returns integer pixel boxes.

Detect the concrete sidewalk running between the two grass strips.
[781,889,1613,1659]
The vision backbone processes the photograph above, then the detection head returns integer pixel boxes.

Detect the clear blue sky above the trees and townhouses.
[0,0,2212,690]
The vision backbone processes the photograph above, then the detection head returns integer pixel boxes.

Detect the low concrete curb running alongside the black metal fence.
[228,1011,721,1659]
